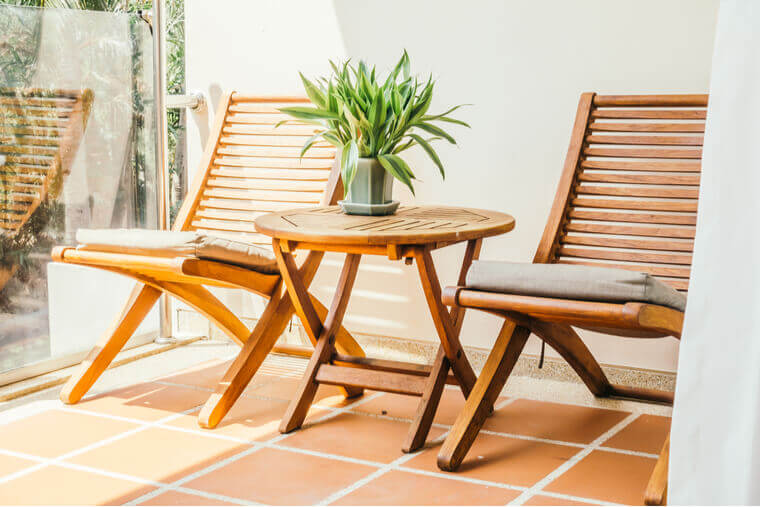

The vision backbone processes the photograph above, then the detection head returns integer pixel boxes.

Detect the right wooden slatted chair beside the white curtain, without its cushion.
[438,93,708,504]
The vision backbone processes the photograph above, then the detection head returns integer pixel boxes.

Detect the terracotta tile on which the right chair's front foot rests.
[404,433,579,487]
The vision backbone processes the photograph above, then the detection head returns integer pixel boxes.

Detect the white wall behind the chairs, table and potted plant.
[186,0,717,370]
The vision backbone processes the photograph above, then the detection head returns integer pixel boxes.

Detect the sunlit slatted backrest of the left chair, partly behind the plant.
[174,92,343,245]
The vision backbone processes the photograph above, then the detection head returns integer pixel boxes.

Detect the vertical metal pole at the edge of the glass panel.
[153,0,175,343]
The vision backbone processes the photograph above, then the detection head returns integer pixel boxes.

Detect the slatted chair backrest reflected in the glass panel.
[0,88,93,234]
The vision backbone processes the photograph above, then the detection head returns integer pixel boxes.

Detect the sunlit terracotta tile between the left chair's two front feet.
[76,382,209,421]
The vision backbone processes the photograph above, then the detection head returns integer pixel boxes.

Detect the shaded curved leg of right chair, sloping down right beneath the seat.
[530,319,613,396]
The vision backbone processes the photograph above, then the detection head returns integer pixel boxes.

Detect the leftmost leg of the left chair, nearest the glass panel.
[60,284,161,404]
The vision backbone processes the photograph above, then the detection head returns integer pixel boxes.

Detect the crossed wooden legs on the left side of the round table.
[275,249,361,433]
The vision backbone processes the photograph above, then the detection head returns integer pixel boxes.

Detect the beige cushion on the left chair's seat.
[77,229,279,273]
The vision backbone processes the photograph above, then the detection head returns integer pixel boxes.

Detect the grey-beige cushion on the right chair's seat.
[467,261,686,311]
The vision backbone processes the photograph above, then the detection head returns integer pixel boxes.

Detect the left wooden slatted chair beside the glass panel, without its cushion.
[53,92,363,428]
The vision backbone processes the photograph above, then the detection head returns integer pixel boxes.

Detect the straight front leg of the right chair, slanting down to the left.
[438,320,530,471]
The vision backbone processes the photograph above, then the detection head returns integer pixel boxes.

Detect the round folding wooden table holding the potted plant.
[255,206,515,452]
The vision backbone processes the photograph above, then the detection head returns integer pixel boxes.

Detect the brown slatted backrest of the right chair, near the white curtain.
[534,93,708,292]
